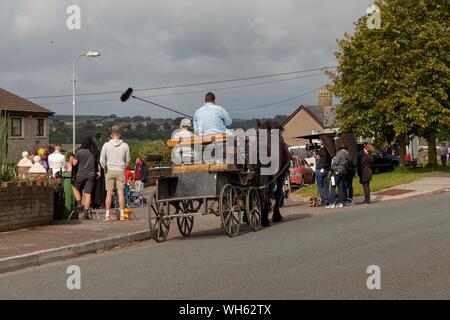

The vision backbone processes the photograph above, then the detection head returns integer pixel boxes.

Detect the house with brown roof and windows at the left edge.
[0,88,53,162]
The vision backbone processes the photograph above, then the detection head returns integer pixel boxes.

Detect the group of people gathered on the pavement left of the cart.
[18,127,147,221]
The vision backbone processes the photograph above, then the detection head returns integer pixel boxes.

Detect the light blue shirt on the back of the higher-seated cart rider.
[194,103,232,135]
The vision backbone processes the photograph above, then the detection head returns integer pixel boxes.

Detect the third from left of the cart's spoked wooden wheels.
[219,184,241,237]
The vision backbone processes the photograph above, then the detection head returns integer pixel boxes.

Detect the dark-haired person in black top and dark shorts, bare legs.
[72,137,100,219]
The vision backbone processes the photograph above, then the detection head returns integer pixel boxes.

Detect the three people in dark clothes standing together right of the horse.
[316,141,374,208]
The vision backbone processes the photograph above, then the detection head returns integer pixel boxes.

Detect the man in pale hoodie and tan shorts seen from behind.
[100,127,130,221]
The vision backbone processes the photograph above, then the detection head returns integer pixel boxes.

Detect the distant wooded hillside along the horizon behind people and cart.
[49,114,288,144]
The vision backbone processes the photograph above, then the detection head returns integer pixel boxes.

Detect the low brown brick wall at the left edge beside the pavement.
[0,182,53,232]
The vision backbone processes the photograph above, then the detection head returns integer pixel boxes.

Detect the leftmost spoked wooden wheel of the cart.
[148,192,170,242]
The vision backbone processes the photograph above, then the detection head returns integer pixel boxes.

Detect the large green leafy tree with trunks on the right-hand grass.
[328,0,450,168]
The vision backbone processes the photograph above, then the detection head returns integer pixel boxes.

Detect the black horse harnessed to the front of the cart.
[256,120,291,226]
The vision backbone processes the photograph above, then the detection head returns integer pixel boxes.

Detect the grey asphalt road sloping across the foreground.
[0,193,450,299]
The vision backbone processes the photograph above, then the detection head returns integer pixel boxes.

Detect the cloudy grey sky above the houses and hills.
[0,0,372,118]
